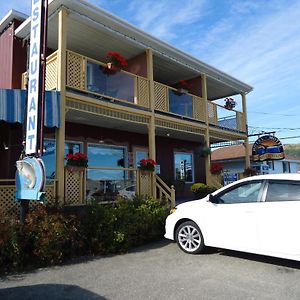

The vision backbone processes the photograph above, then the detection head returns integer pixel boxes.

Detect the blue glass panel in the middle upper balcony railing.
[169,90,193,118]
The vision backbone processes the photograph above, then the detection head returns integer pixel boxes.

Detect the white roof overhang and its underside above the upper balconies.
[16,0,253,100]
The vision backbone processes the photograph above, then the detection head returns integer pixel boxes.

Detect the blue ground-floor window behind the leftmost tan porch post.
[42,139,82,180]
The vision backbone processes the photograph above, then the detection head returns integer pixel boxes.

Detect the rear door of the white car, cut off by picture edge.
[258,180,300,257]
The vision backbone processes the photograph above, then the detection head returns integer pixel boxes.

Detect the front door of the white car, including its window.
[205,180,263,251]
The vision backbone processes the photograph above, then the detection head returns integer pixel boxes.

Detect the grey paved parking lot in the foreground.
[0,240,300,300]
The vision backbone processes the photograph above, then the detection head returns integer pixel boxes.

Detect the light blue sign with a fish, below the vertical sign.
[15,157,46,201]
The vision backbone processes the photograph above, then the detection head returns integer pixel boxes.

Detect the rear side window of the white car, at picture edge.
[266,181,300,202]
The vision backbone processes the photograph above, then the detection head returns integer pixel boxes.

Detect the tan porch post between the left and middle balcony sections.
[146,49,156,197]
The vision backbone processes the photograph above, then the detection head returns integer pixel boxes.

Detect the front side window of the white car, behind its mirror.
[216,181,262,204]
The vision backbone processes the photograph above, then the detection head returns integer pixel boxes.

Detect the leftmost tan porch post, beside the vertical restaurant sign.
[55,8,67,203]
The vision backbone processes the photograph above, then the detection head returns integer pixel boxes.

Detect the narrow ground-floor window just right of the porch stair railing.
[174,152,194,182]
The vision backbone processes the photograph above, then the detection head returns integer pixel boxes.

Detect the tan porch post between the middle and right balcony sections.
[201,74,211,185]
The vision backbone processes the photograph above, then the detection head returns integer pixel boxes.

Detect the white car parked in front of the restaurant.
[165,174,300,260]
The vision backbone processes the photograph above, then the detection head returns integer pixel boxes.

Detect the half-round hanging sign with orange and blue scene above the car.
[252,135,284,161]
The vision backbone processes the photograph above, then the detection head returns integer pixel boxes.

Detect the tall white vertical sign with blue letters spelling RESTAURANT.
[25,0,43,154]
